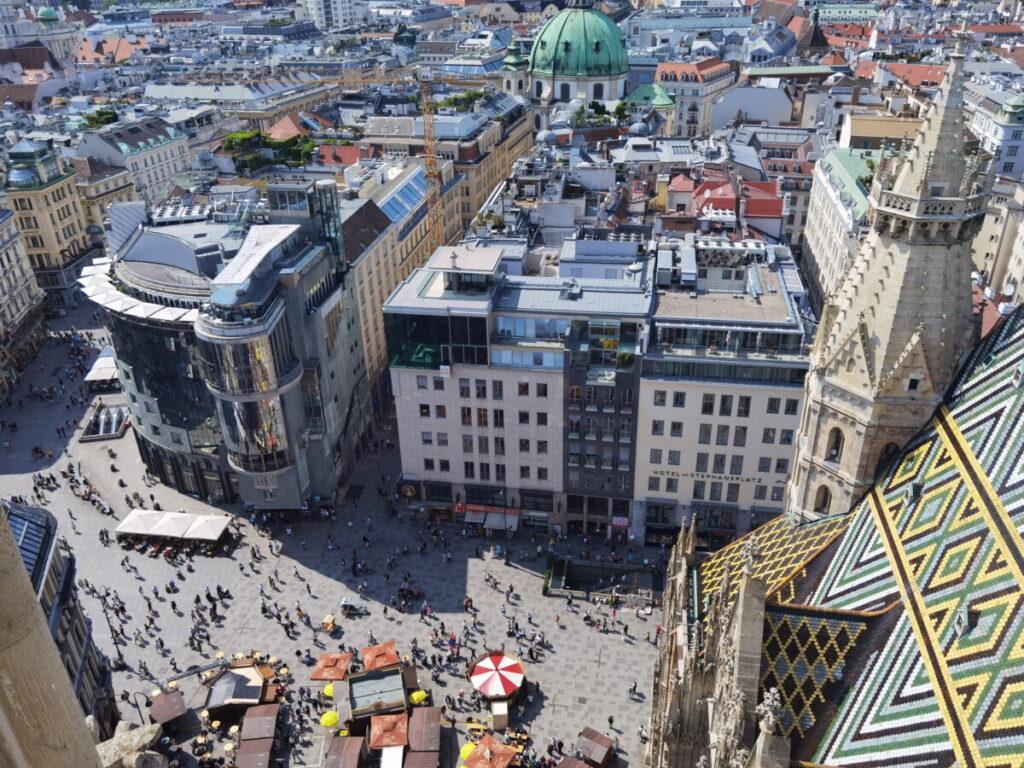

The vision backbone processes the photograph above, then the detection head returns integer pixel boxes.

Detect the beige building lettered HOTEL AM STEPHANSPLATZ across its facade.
[633,234,809,548]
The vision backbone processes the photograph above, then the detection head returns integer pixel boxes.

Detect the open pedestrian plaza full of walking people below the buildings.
[0,308,665,766]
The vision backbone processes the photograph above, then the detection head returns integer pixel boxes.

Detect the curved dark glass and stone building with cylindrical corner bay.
[81,182,371,510]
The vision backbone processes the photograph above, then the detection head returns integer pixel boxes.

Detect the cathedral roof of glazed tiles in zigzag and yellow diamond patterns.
[737,311,1024,768]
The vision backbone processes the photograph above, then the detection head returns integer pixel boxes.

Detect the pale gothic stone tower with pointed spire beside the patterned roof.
[785,40,986,521]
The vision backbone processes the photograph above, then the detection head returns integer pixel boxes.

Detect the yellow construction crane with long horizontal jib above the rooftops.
[198,67,487,253]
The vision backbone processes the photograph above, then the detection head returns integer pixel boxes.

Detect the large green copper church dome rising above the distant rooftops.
[529,0,630,77]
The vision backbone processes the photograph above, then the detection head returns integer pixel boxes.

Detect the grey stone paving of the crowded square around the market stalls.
[0,310,658,766]
